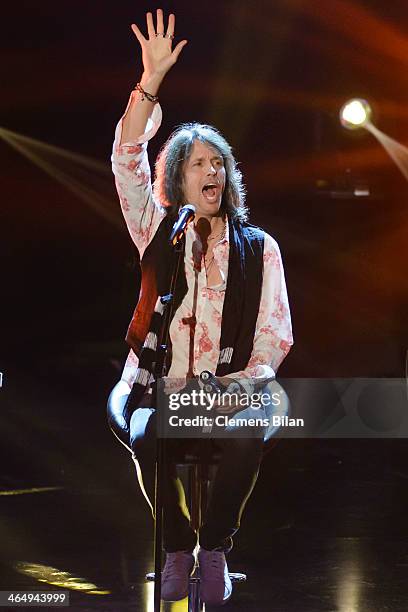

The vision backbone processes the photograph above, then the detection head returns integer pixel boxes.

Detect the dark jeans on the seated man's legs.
[131,408,264,553]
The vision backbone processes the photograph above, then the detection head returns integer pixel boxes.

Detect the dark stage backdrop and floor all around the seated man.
[0,0,408,612]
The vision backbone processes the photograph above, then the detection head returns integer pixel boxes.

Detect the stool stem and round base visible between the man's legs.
[146,440,246,612]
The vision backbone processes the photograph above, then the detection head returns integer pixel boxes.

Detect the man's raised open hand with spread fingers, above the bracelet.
[131,9,187,80]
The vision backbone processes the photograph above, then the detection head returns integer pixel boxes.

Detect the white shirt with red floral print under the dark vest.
[112,94,293,386]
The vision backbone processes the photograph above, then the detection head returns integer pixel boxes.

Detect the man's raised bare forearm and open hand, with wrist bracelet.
[120,9,187,144]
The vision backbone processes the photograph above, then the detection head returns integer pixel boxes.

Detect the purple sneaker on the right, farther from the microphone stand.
[198,548,232,606]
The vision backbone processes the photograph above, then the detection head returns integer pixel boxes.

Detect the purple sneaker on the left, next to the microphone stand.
[161,550,195,601]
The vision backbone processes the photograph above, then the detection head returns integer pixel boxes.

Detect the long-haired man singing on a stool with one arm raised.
[112,9,293,605]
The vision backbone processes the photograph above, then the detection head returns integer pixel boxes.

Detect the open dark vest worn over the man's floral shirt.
[126,215,264,376]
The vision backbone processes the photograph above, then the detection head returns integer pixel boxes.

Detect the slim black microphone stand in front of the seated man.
[152,232,185,612]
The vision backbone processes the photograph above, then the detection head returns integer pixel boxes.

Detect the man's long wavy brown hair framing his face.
[153,123,248,222]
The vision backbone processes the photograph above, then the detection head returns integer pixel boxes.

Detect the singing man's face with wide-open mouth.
[183,140,225,217]
